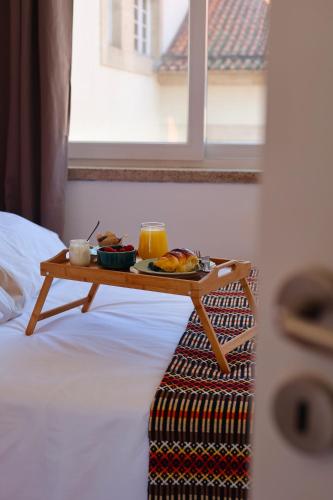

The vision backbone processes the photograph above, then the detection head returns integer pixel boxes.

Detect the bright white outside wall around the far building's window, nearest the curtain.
[70,0,159,141]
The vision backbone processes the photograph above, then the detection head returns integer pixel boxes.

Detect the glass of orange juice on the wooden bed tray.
[138,222,168,259]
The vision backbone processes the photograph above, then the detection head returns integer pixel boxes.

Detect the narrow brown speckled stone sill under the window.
[68,166,261,184]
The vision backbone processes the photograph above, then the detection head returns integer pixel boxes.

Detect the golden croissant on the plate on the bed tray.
[154,248,199,273]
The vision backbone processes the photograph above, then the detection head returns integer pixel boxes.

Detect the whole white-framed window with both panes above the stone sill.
[70,0,269,168]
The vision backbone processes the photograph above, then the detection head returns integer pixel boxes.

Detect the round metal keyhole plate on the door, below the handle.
[273,376,333,454]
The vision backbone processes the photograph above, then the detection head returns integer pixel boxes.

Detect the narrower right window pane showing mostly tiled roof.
[206,0,269,143]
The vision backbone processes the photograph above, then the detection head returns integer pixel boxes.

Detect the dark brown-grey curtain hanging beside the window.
[0,0,73,234]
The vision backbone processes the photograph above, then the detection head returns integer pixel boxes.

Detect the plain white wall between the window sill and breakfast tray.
[64,181,260,260]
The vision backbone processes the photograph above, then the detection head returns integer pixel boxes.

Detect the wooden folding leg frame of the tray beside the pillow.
[25,276,99,335]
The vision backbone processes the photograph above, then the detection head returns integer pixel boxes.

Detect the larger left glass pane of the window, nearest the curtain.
[70,0,188,142]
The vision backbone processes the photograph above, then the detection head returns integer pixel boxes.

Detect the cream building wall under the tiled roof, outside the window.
[159,74,265,142]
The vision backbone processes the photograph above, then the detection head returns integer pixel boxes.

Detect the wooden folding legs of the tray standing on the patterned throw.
[192,278,256,374]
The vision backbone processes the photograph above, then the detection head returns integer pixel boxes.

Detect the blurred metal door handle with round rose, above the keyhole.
[277,269,333,353]
